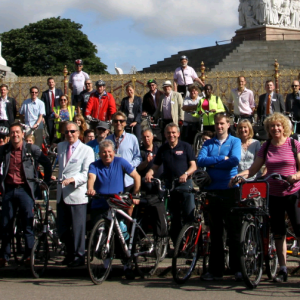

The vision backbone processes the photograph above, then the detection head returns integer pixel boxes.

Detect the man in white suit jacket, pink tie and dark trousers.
[57,122,95,267]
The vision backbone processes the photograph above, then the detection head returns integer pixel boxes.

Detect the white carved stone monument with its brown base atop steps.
[233,0,300,42]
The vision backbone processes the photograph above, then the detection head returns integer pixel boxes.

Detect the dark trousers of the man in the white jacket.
[57,199,87,259]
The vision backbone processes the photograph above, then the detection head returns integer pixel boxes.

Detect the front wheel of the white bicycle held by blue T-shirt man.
[87,219,115,284]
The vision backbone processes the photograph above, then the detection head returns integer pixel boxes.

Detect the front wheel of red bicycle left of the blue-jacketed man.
[172,224,199,284]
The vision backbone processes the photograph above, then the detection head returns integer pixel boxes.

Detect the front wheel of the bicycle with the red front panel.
[240,221,263,289]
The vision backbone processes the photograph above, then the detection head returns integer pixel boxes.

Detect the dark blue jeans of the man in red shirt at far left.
[1,185,34,261]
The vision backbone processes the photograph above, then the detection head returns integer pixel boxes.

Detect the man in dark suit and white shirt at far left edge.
[0,84,17,127]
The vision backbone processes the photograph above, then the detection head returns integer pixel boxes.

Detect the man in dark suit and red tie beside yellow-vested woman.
[41,77,63,143]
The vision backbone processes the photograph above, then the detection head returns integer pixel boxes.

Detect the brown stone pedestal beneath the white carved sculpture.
[232,25,300,42]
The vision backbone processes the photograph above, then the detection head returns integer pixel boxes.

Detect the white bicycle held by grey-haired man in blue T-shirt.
[87,194,161,284]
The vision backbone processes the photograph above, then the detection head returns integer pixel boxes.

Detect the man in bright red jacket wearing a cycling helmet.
[85,80,117,125]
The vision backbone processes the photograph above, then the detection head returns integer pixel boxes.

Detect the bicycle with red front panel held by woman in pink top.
[232,173,285,289]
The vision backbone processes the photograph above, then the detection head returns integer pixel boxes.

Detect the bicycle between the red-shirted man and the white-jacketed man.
[30,179,62,278]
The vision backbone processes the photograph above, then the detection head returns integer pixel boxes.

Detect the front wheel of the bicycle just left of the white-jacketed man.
[30,233,49,278]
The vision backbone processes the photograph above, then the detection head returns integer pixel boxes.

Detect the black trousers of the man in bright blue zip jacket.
[207,189,242,277]
